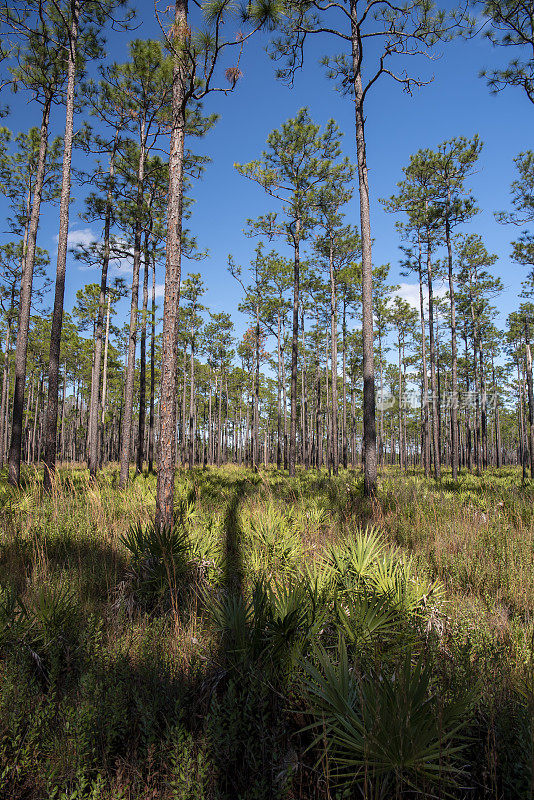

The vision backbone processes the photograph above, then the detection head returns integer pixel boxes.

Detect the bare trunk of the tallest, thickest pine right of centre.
[350,14,377,497]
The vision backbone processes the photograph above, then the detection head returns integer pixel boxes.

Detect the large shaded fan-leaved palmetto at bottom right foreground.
[304,639,470,797]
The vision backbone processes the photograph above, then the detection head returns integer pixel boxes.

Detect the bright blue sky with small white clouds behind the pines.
[4,3,532,356]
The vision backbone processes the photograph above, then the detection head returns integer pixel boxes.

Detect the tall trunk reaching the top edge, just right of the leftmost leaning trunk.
[43,6,80,491]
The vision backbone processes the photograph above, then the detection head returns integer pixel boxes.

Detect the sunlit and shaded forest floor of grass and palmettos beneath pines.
[0,465,534,800]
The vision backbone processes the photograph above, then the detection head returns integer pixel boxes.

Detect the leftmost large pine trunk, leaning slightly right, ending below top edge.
[6,91,52,486]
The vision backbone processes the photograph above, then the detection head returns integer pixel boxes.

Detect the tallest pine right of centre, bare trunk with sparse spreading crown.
[272,0,463,495]
